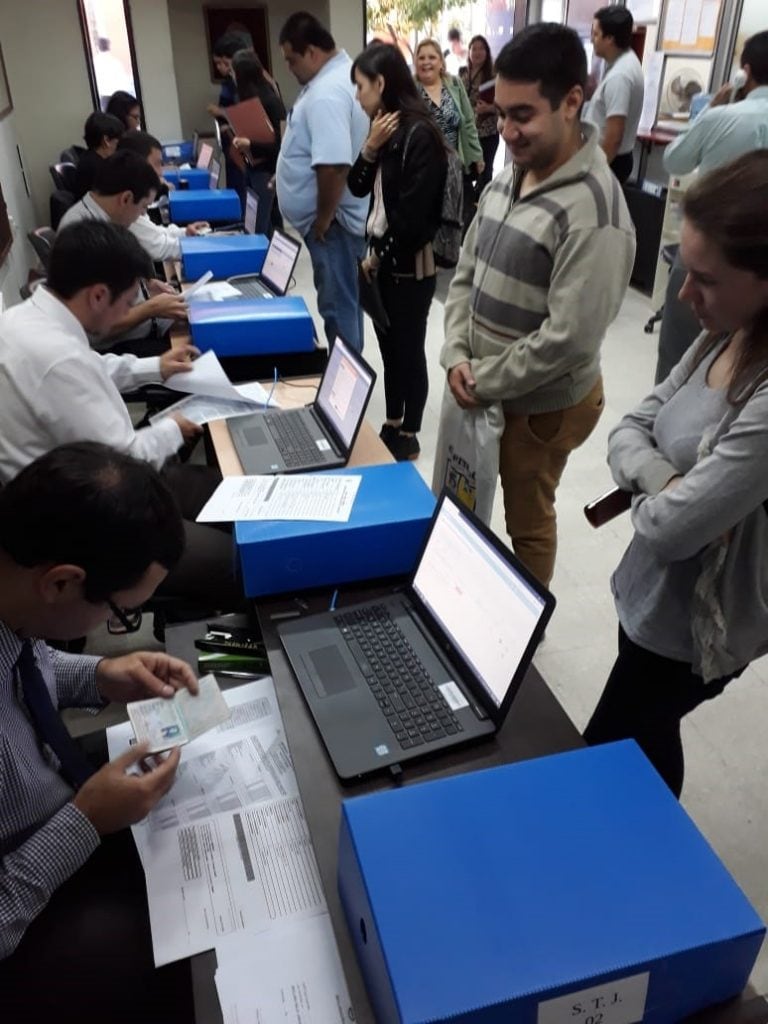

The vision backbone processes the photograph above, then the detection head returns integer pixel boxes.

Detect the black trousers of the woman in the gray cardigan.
[584,626,746,797]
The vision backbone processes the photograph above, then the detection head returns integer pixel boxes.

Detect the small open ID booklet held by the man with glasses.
[126,675,230,754]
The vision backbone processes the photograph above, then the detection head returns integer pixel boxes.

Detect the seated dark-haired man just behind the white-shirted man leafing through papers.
[58,152,186,355]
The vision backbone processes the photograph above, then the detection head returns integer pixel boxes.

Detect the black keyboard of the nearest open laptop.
[334,604,463,750]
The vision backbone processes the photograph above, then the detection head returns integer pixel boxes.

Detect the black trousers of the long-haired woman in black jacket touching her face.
[374,269,435,434]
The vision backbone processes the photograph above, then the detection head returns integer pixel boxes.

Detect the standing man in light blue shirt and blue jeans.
[276,11,369,351]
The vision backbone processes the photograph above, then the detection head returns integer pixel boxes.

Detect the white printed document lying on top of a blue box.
[198,473,362,522]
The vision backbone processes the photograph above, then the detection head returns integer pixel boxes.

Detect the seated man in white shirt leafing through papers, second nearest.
[0,220,242,610]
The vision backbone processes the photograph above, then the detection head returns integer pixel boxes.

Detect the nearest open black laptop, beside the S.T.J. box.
[279,492,555,780]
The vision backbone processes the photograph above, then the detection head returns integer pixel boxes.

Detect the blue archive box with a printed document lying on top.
[234,462,435,597]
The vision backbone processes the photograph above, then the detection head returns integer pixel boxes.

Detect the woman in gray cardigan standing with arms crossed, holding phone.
[584,151,768,796]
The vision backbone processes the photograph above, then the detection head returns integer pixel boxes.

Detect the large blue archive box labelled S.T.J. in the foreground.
[339,745,765,1024]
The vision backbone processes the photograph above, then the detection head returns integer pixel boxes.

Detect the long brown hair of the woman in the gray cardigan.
[683,150,768,406]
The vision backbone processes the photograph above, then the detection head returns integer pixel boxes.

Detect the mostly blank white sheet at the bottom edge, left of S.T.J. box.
[216,913,354,1024]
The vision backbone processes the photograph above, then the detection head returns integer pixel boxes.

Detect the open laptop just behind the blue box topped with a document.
[226,338,376,475]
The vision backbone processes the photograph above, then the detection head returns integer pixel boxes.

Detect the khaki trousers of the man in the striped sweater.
[499,378,604,586]
